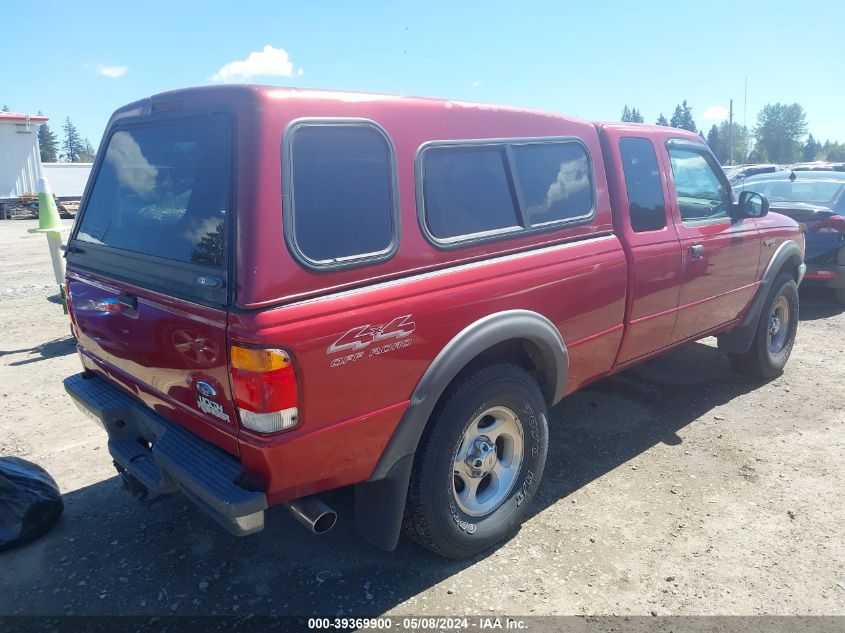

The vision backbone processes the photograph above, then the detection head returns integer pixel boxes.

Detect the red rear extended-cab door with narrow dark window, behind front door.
[602,126,682,365]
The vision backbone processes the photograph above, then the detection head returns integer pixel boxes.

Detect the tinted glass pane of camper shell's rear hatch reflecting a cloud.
[76,116,231,268]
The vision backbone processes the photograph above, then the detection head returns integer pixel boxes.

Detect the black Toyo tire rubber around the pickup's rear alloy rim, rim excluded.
[403,364,549,559]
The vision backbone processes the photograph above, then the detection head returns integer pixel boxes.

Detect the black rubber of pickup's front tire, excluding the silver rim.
[730,273,798,380]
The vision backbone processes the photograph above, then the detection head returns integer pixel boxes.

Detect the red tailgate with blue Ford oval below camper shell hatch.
[68,271,237,454]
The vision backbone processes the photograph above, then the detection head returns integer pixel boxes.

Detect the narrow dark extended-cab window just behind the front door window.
[619,138,666,233]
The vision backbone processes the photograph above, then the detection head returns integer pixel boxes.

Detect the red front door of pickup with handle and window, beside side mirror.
[664,140,760,343]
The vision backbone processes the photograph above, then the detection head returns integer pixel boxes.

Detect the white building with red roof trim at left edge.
[0,112,47,199]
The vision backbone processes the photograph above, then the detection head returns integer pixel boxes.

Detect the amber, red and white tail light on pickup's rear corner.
[231,345,298,433]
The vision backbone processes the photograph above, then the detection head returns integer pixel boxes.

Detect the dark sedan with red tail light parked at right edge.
[737,171,845,304]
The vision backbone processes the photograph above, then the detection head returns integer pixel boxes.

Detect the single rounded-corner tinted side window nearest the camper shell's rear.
[285,123,398,266]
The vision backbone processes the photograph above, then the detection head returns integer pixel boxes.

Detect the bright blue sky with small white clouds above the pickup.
[0,0,845,147]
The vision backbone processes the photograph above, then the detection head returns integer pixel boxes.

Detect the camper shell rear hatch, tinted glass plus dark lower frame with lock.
[67,113,234,305]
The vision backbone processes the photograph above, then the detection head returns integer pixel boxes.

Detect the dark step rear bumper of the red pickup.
[64,374,267,536]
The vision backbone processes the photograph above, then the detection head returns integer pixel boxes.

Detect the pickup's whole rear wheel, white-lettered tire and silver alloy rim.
[404,364,548,559]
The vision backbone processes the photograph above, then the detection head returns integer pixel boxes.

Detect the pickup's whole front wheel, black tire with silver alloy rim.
[730,273,798,379]
